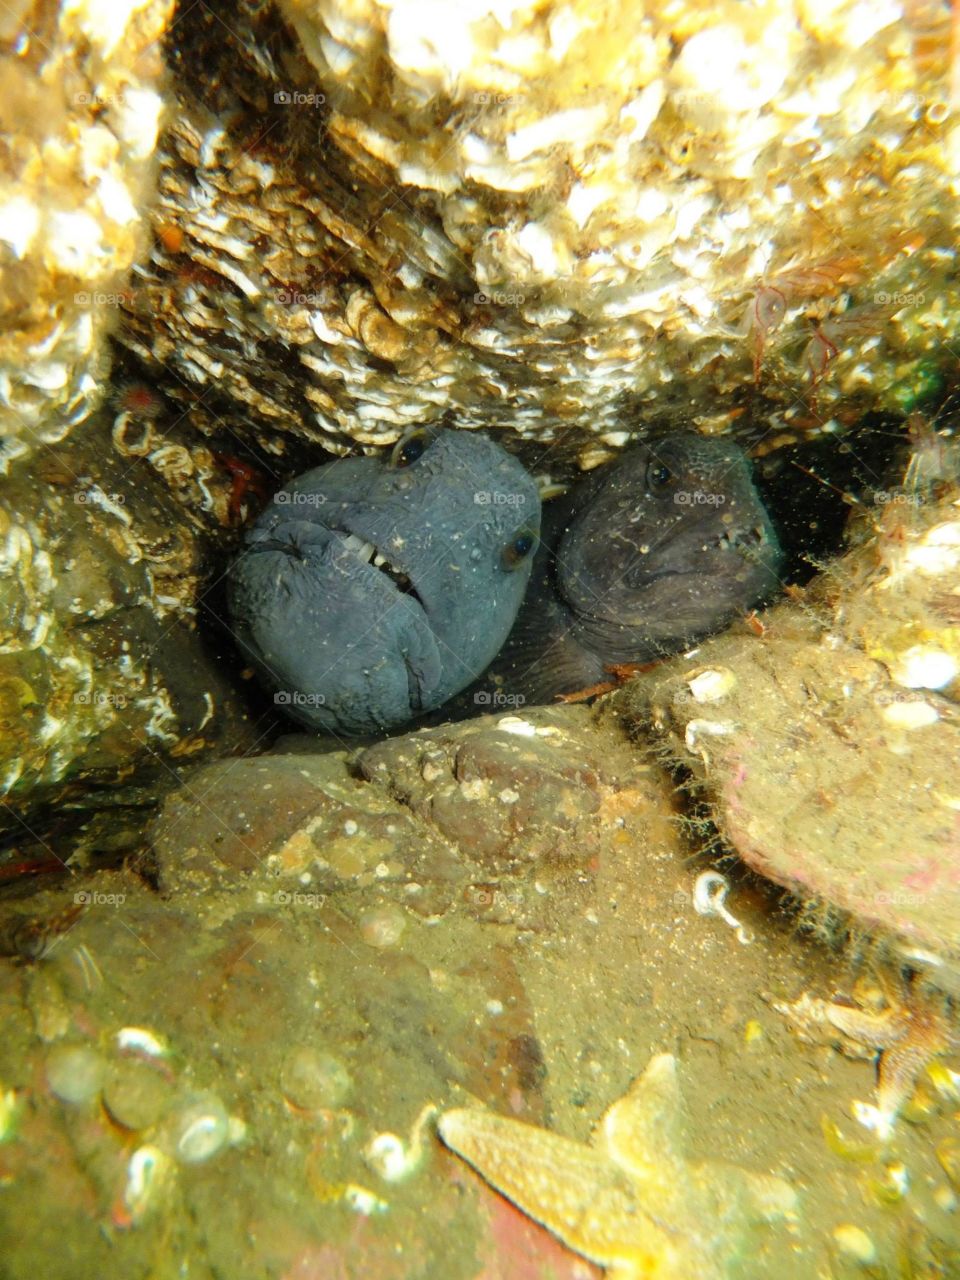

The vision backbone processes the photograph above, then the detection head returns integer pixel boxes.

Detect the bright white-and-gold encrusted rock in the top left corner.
[0,0,174,474]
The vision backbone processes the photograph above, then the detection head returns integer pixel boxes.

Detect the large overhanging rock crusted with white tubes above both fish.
[122,0,960,466]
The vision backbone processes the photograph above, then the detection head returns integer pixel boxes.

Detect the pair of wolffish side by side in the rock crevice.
[228,430,781,736]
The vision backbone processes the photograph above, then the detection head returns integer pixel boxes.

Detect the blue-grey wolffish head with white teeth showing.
[229,430,540,735]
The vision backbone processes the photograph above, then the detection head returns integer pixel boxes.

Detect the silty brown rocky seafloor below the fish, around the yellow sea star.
[0,707,960,1280]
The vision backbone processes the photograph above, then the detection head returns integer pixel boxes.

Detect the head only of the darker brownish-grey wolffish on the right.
[557,433,781,660]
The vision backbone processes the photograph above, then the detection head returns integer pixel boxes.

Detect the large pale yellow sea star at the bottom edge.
[439,1053,796,1280]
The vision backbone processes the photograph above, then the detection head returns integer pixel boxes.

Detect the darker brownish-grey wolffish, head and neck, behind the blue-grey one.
[484,431,781,703]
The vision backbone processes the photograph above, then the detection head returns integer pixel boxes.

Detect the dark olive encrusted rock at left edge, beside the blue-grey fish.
[0,415,262,837]
